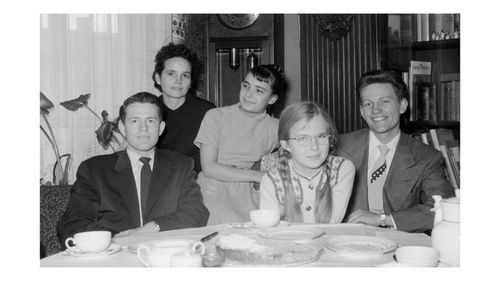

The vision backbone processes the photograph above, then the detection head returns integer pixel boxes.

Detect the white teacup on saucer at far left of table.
[64,231,111,253]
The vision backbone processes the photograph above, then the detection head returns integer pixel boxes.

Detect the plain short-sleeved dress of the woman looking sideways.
[194,104,279,225]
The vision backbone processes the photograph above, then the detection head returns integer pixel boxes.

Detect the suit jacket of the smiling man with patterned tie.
[338,129,454,232]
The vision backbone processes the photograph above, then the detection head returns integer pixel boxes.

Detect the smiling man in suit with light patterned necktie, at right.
[338,70,454,232]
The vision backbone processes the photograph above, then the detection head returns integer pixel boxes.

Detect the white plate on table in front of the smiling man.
[326,236,398,256]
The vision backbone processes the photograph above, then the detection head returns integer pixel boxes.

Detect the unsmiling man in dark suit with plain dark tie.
[57,92,209,244]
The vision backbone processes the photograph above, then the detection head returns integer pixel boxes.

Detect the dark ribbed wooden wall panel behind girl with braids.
[300,14,381,133]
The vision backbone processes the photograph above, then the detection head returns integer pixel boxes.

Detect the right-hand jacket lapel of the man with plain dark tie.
[146,149,173,220]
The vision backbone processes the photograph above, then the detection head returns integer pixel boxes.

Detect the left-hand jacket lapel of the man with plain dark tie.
[114,150,141,227]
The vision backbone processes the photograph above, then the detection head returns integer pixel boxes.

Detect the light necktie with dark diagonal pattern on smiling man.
[368,144,389,213]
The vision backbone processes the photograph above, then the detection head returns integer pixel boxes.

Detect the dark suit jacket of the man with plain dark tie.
[57,149,209,245]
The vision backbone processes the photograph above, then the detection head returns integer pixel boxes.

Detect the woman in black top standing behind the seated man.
[153,43,215,172]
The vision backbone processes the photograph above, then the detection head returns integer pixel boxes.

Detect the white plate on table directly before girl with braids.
[259,226,325,241]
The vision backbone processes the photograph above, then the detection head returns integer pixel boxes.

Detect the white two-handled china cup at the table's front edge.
[137,239,205,267]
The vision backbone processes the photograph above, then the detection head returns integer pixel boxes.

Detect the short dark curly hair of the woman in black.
[153,43,203,94]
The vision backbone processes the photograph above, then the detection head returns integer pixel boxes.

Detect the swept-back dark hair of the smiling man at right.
[356,69,408,103]
